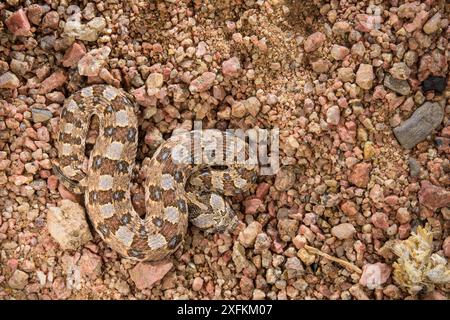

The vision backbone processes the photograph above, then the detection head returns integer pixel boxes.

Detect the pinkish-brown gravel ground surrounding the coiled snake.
[0,0,450,299]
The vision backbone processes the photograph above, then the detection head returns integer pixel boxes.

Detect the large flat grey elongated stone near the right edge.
[393,102,444,149]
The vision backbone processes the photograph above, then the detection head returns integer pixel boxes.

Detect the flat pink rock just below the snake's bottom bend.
[130,262,173,290]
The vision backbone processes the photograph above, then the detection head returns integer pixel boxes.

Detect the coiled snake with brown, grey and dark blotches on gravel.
[52,84,258,261]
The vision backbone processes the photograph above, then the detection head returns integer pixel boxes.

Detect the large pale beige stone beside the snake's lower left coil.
[47,200,92,250]
